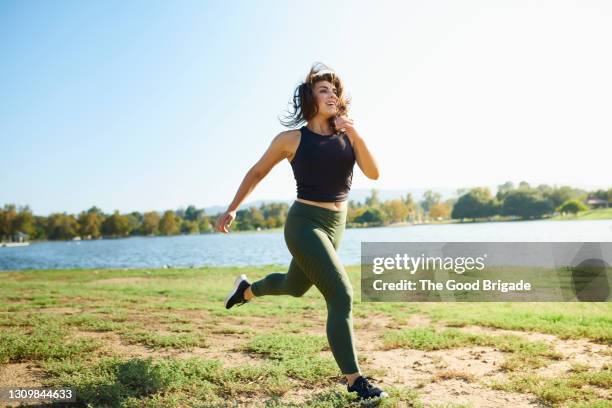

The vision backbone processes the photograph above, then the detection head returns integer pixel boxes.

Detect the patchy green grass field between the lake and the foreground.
[0,265,612,408]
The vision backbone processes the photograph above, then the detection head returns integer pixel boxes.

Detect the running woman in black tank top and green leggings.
[215,63,387,398]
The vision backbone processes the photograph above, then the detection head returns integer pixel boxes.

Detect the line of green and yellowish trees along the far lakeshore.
[0,181,612,241]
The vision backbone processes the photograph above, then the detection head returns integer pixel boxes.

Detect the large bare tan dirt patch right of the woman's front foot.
[352,315,612,408]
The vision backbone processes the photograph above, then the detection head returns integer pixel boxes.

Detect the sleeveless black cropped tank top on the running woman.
[291,126,355,202]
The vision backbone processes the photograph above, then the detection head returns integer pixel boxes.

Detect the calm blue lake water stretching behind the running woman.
[0,220,612,271]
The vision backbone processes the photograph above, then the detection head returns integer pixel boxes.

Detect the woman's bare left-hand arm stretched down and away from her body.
[215,131,291,233]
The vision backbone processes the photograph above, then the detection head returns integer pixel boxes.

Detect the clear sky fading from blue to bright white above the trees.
[0,0,612,215]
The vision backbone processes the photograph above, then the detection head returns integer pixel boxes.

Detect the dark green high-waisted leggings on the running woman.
[251,201,359,374]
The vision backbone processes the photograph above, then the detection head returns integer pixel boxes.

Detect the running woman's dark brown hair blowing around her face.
[279,62,350,132]
